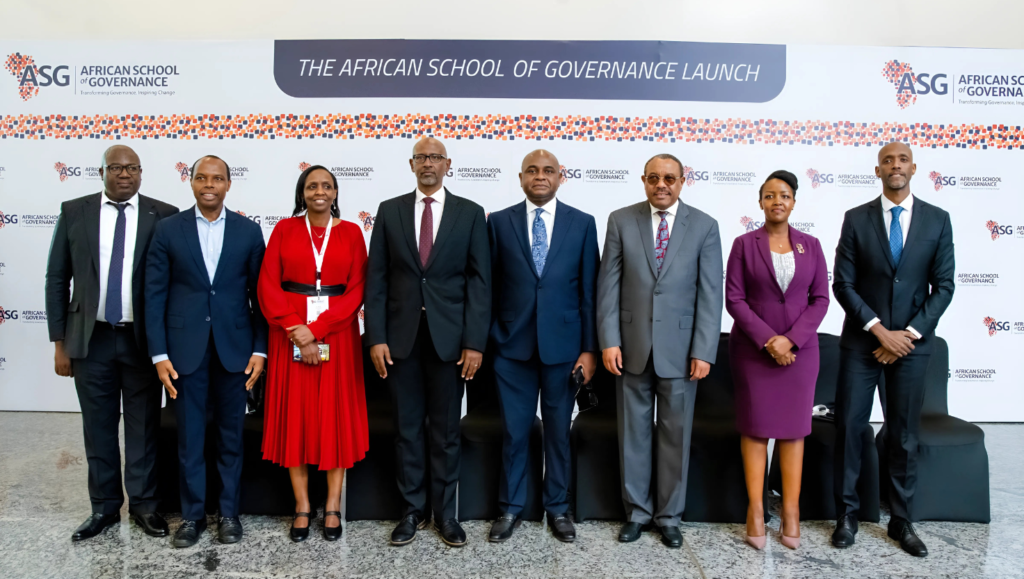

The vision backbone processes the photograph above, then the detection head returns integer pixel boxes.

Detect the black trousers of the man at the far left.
[72,322,163,514]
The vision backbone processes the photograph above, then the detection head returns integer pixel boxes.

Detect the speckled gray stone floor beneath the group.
[0,413,1024,579]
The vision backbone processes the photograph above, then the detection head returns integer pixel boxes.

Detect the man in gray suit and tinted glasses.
[597,155,722,548]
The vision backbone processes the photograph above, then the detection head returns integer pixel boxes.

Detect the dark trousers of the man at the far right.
[835,346,931,521]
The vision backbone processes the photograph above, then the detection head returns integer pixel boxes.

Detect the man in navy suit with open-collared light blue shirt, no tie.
[145,155,267,547]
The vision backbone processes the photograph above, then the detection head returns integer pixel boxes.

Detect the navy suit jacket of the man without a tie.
[145,206,267,374]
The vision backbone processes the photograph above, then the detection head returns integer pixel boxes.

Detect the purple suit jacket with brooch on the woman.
[725,228,828,356]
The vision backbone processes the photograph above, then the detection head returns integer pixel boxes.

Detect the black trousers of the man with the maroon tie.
[387,315,463,524]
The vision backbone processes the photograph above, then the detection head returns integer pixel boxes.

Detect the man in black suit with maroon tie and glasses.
[365,138,490,546]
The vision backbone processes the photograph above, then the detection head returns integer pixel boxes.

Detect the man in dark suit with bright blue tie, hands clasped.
[833,142,953,556]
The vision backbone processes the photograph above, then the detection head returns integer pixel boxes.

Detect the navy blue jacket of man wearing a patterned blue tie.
[487,201,601,364]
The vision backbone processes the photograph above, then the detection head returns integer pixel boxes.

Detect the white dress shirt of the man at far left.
[96,194,138,323]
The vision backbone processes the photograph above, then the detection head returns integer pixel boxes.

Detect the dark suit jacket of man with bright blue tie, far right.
[833,192,954,354]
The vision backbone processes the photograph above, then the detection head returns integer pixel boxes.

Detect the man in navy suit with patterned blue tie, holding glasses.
[487,150,600,542]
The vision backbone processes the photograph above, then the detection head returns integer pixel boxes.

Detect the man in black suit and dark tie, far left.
[46,144,178,541]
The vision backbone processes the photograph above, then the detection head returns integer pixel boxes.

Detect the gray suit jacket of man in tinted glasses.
[597,200,722,378]
